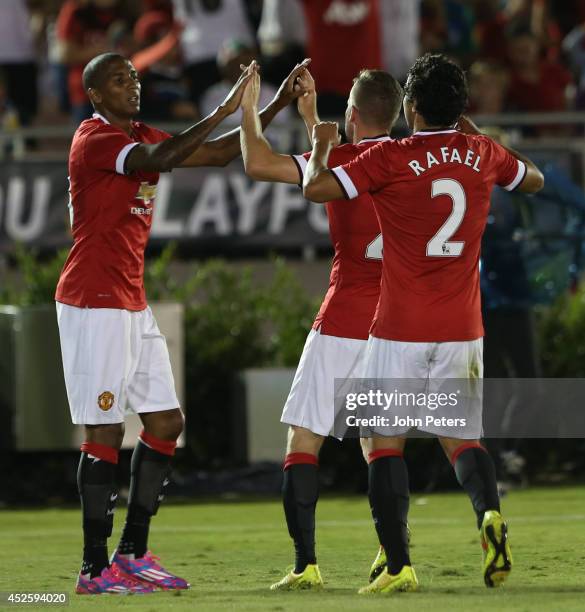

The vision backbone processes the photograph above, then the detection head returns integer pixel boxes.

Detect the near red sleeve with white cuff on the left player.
[83,126,140,174]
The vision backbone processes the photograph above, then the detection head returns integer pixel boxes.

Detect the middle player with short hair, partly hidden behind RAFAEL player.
[241,70,402,590]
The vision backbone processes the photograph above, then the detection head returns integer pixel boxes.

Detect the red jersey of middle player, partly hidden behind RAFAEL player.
[293,136,390,340]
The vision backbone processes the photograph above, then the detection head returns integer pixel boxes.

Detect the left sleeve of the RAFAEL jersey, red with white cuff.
[332,141,394,200]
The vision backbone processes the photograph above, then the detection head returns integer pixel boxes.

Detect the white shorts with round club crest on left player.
[57,302,179,425]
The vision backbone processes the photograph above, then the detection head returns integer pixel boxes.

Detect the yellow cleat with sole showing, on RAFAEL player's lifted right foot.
[480,510,512,587]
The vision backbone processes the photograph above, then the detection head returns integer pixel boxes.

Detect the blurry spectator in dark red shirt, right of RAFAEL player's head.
[508,26,572,112]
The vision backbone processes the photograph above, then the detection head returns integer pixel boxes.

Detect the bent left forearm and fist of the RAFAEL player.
[303,122,345,202]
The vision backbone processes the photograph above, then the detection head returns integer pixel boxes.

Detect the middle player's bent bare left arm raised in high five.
[240,72,299,184]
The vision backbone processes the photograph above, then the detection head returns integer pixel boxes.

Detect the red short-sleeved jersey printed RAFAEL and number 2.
[333,130,526,342]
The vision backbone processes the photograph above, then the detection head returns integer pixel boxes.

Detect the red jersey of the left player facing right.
[55,114,170,310]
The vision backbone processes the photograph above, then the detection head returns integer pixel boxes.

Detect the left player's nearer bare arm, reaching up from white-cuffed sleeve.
[125,62,256,172]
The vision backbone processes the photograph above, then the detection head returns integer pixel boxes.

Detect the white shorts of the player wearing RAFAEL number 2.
[362,336,483,439]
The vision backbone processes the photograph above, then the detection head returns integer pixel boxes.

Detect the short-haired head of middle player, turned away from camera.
[351,70,403,131]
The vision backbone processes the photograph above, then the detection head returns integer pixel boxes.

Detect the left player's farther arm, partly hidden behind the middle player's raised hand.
[181,59,311,167]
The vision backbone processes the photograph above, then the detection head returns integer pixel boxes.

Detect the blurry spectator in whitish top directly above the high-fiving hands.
[258,0,307,85]
